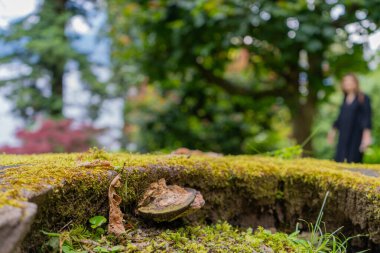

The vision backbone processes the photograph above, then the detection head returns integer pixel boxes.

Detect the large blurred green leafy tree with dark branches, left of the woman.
[109,0,380,153]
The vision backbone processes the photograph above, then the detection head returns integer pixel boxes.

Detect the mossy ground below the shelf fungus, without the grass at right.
[42,222,306,253]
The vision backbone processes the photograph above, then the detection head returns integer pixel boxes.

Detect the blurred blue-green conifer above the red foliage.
[0,0,105,119]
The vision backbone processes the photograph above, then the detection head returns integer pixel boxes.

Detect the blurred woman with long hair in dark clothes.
[328,74,372,163]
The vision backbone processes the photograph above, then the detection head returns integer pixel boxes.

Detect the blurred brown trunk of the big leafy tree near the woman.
[291,96,317,156]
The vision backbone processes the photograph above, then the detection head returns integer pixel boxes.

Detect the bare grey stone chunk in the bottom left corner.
[0,202,37,253]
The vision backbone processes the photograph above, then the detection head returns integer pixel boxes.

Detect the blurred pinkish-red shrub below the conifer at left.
[0,119,103,154]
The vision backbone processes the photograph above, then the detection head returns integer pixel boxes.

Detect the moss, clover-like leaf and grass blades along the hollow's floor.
[42,195,366,253]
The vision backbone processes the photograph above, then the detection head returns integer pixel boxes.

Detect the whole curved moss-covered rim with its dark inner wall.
[0,150,380,252]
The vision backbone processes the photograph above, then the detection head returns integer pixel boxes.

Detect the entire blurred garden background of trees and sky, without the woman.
[0,0,380,163]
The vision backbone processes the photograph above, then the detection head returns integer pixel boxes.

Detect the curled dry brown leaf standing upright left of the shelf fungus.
[108,175,125,236]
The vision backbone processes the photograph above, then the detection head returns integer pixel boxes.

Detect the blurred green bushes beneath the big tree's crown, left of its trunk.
[125,84,290,154]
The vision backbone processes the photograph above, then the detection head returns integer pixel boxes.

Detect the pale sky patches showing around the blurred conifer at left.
[0,0,122,150]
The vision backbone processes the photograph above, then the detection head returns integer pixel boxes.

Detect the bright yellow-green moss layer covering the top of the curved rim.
[0,152,380,211]
